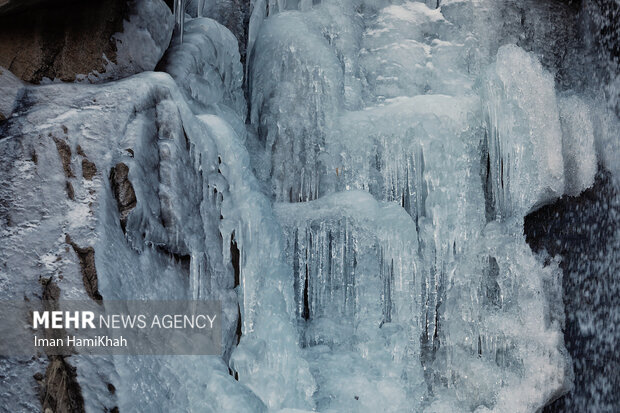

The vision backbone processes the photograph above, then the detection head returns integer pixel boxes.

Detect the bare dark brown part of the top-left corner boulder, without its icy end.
[0,0,127,83]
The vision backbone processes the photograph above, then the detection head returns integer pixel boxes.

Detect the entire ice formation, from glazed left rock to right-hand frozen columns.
[0,0,618,413]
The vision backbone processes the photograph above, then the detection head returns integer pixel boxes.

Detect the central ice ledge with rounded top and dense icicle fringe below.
[276,191,423,412]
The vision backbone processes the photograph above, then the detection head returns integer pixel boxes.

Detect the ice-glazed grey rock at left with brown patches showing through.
[0,73,262,411]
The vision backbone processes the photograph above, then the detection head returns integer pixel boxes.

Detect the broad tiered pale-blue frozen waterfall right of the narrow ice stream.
[243,0,596,412]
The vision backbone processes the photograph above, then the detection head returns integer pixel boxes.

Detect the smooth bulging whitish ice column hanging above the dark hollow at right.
[486,46,564,217]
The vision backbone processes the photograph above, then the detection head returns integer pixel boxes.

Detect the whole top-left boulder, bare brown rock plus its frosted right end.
[0,0,172,83]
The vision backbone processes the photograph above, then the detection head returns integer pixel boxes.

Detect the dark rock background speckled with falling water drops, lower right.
[524,171,620,413]
